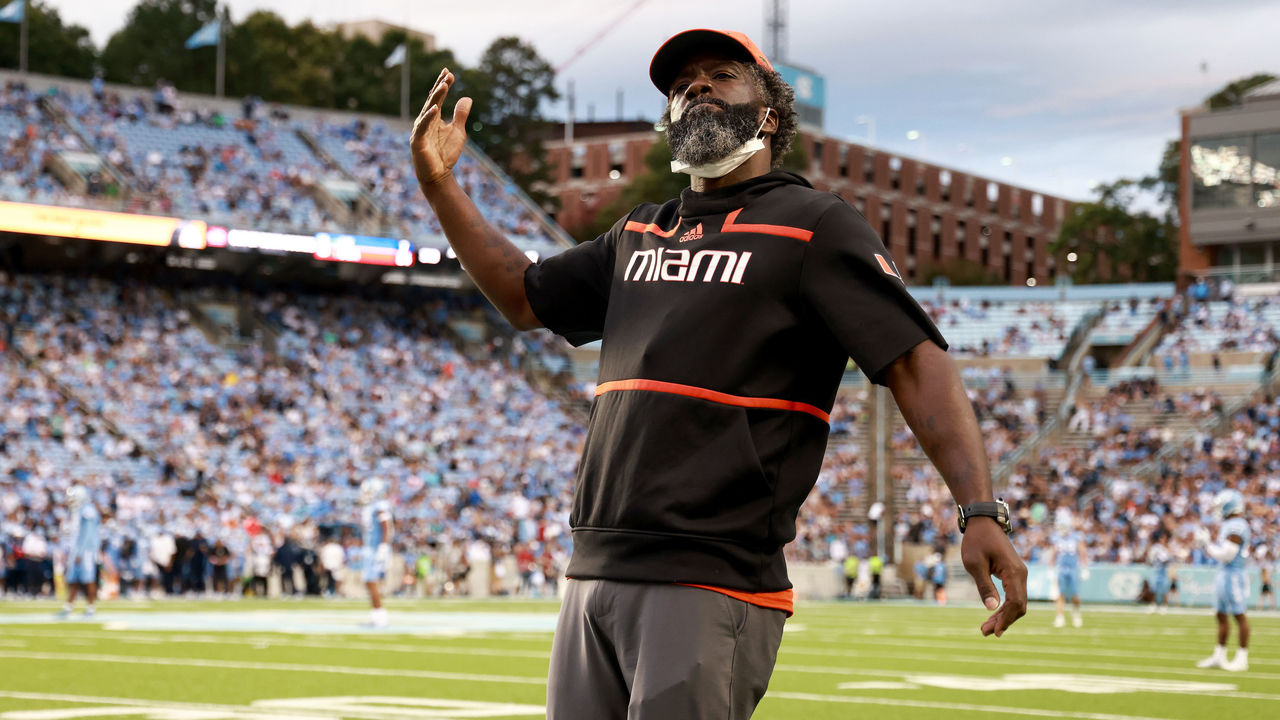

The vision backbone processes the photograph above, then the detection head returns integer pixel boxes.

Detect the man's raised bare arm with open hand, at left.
[410,68,543,331]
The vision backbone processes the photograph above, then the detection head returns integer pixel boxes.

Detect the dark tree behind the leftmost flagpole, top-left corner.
[0,0,97,78]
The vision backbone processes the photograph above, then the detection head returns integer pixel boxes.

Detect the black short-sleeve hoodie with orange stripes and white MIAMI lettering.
[525,172,946,592]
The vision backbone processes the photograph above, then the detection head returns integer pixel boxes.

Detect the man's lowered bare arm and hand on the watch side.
[882,340,1027,637]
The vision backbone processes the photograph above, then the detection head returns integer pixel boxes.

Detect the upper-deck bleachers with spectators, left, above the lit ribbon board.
[0,81,558,255]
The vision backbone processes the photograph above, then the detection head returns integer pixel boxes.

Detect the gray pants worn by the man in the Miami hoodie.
[547,580,786,720]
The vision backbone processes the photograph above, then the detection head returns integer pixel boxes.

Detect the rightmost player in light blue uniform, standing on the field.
[1196,489,1249,671]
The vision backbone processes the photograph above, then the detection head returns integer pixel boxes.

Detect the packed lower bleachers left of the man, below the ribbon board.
[0,269,581,592]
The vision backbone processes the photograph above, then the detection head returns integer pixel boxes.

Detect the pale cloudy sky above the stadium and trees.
[55,0,1280,200]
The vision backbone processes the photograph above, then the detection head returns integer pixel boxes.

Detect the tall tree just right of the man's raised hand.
[463,37,559,209]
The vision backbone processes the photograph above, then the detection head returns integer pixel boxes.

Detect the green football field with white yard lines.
[0,601,1280,720]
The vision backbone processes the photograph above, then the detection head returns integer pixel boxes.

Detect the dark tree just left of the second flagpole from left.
[102,0,218,94]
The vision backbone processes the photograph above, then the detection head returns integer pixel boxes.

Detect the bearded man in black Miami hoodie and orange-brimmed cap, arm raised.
[411,29,1027,720]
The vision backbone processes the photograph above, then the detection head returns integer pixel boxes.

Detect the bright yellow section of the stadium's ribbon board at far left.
[0,202,205,247]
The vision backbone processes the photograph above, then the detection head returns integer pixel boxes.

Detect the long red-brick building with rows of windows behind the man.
[545,120,1069,284]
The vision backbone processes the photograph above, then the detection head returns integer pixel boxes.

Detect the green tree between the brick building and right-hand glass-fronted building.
[1050,178,1178,283]
